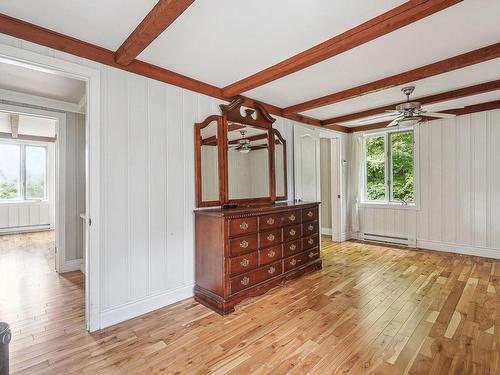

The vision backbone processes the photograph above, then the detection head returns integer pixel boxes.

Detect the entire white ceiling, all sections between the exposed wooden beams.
[0,0,500,126]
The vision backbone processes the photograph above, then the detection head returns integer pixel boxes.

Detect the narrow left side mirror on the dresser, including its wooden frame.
[195,116,221,207]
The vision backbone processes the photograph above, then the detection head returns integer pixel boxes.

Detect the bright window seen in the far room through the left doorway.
[0,143,47,202]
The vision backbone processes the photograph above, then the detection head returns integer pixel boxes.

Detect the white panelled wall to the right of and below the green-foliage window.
[360,110,500,258]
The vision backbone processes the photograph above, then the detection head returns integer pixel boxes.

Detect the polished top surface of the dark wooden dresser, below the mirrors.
[194,202,319,217]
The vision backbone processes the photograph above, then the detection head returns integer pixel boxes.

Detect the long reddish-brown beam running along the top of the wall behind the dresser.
[0,13,338,132]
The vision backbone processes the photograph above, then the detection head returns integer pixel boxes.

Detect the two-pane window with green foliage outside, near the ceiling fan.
[364,130,415,204]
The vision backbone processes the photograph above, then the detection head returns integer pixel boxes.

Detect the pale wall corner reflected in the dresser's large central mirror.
[228,149,270,199]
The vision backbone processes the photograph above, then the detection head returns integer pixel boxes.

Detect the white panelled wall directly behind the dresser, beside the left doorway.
[0,34,293,327]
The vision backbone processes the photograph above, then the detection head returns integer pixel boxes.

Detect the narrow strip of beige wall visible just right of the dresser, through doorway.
[319,138,332,230]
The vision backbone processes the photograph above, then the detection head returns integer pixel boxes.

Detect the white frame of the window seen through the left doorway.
[0,139,49,204]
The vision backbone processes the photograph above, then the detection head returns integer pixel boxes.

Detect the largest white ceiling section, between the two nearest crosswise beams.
[139,0,404,87]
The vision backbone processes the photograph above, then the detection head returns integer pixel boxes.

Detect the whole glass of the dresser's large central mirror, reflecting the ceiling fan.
[227,123,271,201]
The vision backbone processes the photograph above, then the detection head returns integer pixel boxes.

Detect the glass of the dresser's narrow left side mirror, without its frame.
[199,121,219,202]
